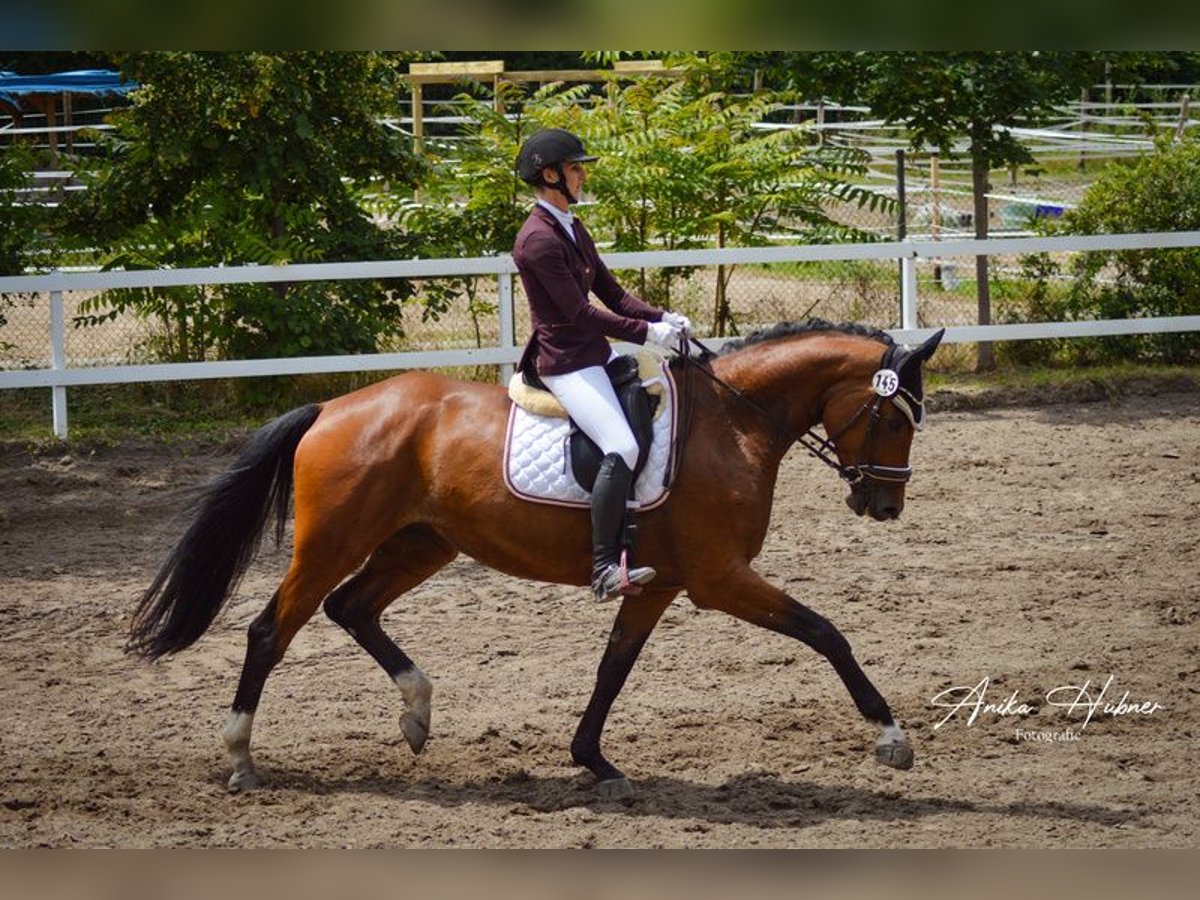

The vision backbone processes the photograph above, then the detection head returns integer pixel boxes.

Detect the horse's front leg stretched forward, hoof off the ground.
[689,566,913,769]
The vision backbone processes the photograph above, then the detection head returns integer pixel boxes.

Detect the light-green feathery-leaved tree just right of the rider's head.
[583,65,888,335]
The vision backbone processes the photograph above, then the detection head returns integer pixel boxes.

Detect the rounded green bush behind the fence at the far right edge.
[1024,138,1200,362]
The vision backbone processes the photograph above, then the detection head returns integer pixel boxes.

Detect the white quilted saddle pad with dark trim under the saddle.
[504,364,677,511]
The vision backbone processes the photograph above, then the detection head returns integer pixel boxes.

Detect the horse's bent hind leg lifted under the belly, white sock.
[325,526,458,754]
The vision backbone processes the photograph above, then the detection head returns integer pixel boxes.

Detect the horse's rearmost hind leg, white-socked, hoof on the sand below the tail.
[222,551,354,792]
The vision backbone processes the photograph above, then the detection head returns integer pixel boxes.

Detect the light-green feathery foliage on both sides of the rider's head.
[389,59,890,331]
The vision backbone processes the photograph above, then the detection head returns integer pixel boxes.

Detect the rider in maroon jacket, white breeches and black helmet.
[512,128,691,600]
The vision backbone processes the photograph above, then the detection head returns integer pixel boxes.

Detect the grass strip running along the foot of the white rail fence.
[0,360,1200,449]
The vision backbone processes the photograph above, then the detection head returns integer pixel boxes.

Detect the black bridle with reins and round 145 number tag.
[679,337,925,487]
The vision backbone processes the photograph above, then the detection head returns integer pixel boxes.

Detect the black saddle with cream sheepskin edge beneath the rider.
[509,356,662,492]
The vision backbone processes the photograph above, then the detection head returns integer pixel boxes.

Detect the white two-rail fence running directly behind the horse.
[0,232,1200,438]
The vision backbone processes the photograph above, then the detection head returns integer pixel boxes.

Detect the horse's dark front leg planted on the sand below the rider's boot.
[571,590,677,799]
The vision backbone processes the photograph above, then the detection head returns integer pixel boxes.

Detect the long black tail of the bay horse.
[125,403,320,659]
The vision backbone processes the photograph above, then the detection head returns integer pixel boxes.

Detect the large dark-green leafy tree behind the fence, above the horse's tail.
[65,52,420,360]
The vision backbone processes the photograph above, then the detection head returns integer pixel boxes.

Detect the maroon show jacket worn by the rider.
[512,206,662,376]
